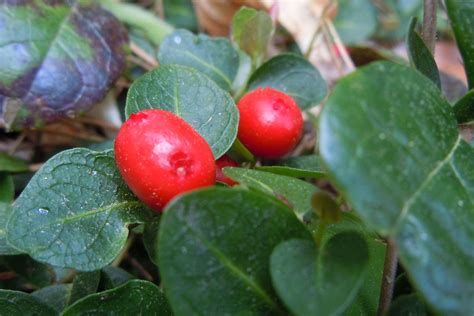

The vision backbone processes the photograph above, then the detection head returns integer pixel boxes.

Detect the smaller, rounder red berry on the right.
[237,88,303,158]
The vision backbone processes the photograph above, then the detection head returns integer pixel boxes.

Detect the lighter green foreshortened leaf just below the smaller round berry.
[223,167,318,218]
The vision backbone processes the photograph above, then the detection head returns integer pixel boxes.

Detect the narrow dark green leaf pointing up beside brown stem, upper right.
[407,18,441,89]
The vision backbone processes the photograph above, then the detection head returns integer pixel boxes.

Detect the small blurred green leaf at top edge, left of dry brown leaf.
[162,0,198,32]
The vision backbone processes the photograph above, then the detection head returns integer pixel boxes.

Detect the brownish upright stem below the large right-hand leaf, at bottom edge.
[377,239,398,316]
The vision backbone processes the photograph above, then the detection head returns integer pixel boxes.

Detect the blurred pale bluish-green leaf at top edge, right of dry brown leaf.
[334,0,377,45]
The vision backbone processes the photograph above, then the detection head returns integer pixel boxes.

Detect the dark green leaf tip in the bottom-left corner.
[0,290,58,316]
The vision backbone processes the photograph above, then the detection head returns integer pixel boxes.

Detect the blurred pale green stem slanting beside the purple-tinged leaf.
[99,0,173,46]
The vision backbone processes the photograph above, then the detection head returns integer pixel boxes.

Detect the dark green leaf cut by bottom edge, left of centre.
[62,280,171,316]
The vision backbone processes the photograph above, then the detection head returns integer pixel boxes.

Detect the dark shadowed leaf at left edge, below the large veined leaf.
[1,255,54,288]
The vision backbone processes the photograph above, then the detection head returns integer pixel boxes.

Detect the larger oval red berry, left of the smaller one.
[115,110,216,210]
